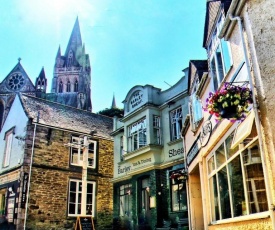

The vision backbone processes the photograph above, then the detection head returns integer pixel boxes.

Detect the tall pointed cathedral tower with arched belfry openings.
[51,17,92,111]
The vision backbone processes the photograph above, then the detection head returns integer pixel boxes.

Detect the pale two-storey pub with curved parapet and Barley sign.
[112,68,191,229]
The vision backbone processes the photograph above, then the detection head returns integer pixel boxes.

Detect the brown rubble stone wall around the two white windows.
[19,126,113,230]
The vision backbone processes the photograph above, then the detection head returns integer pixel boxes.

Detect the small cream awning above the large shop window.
[231,110,255,149]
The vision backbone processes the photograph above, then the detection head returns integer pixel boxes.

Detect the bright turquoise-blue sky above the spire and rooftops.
[0,0,206,112]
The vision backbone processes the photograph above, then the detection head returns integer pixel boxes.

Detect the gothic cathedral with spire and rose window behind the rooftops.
[0,18,92,129]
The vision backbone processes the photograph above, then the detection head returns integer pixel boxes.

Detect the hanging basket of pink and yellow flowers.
[206,83,252,121]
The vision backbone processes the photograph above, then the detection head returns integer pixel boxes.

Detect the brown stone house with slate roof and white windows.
[0,94,113,230]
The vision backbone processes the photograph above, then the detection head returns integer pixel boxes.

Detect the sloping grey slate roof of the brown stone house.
[19,94,113,139]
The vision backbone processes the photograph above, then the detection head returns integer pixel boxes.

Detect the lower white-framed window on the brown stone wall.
[68,180,95,216]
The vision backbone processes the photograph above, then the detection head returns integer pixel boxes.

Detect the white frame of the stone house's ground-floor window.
[67,179,96,216]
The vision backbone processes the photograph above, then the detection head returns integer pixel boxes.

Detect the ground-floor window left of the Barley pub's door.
[119,184,132,217]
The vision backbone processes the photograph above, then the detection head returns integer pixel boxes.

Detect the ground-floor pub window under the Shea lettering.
[170,172,187,212]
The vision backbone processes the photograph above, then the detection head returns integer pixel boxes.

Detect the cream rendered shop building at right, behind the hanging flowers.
[182,0,275,230]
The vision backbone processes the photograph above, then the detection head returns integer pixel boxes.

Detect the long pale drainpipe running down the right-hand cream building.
[229,14,275,229]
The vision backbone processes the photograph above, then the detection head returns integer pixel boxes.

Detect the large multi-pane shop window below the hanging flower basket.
[208,127,268,221]
